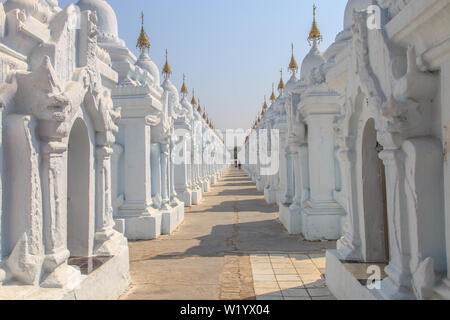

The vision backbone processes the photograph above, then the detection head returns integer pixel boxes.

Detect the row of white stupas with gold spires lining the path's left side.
[0,0,225,299]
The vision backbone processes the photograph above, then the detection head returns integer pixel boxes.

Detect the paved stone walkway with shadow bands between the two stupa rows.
[121,168,335,300]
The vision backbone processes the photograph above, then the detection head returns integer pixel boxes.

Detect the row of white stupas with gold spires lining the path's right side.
[244,0,450,299]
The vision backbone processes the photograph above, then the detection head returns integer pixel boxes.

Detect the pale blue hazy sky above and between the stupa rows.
[59,0,347,129]
